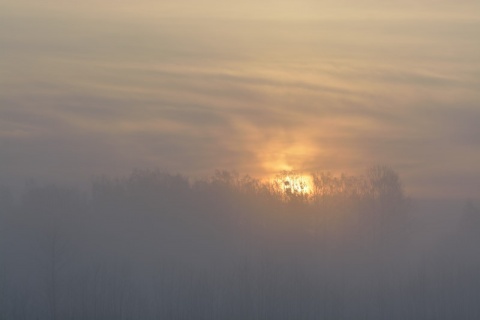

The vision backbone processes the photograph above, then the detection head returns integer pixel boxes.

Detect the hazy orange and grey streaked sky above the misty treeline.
[0,0,480,198]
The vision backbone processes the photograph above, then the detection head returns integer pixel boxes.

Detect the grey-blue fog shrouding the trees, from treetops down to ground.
[0,166,480,320]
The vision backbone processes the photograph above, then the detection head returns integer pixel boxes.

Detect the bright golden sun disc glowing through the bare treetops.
[273,171,314,196]
